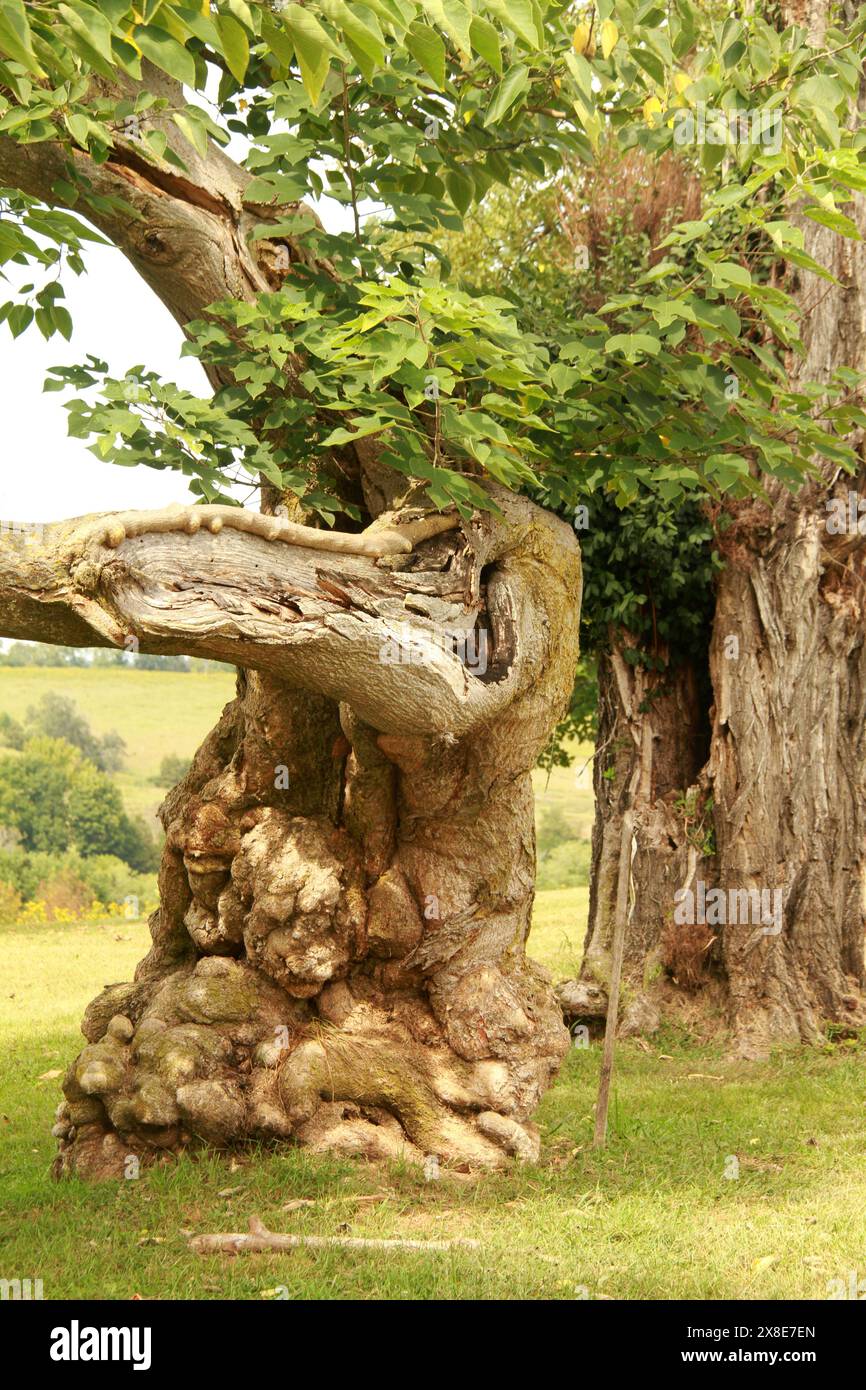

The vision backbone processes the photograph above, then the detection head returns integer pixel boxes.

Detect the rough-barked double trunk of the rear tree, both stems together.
[559,0,866,1056]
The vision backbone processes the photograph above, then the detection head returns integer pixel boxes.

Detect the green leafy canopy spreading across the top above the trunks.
[0,0,866,516]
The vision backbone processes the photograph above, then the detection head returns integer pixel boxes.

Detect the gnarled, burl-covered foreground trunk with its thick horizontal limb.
[0,488,581,1177]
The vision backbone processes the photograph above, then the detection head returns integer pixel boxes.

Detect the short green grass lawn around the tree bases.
[0,900,866,1300]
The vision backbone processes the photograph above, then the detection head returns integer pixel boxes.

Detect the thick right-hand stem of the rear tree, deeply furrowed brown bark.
[710,0,866,1055]
